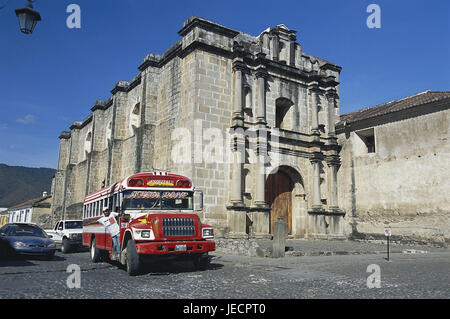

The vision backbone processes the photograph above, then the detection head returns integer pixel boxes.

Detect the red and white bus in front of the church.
[83,172,215,276]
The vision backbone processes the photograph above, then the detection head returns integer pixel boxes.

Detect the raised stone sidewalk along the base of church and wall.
[216,239,449,257]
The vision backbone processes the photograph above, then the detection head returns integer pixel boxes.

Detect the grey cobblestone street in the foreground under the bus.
[0,249,450,299]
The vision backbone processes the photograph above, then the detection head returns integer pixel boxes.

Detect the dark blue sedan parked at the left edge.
[0,223,56,259]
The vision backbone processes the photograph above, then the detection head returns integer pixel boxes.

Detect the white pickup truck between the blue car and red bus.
[45,220,83,254]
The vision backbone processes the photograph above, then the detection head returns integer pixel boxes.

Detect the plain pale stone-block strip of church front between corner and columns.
[191,51,232,235]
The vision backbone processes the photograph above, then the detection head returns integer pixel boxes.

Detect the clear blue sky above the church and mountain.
[0,0,450,168]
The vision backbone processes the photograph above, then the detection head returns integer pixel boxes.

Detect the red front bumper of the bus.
[136,240,216,255]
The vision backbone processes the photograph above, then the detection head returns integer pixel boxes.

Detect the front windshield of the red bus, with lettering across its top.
[123,191,193,210]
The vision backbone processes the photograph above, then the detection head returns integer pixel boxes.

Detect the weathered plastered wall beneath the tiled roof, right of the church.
[339,109,450,242]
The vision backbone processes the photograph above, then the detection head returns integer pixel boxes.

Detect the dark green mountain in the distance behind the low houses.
[0,164,56,207]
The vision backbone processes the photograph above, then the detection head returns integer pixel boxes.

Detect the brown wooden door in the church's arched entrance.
[266,171,293,234]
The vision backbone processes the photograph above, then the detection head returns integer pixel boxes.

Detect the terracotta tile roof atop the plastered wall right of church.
[340,91,450,123]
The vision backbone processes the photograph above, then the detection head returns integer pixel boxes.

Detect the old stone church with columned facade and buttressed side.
[52,17,345,238]
